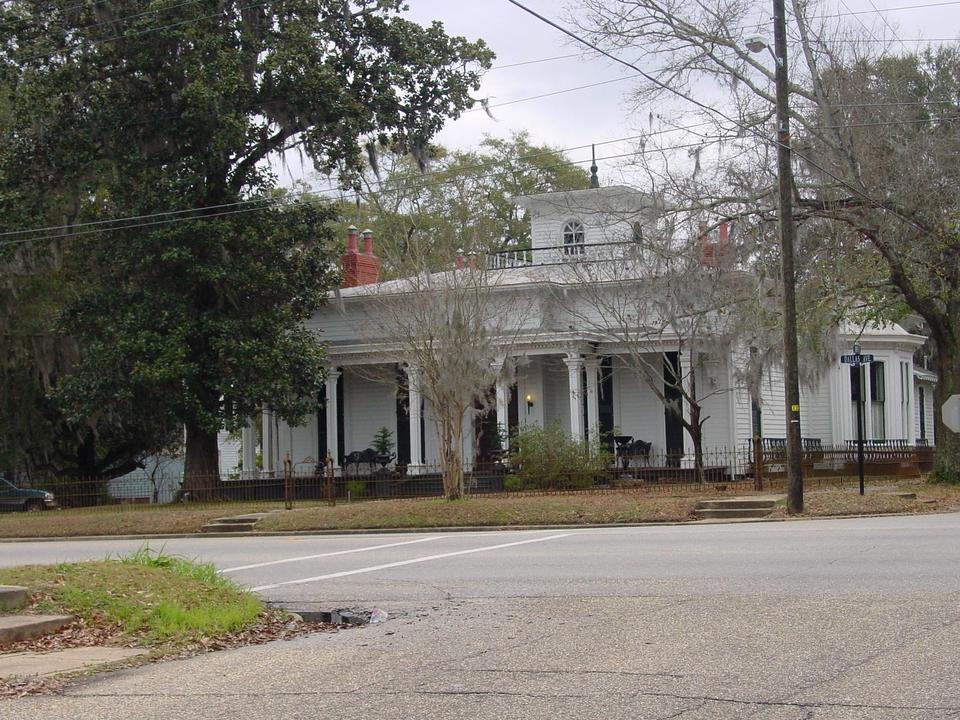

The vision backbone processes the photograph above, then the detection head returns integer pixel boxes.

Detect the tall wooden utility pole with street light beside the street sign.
[745,0,803,514]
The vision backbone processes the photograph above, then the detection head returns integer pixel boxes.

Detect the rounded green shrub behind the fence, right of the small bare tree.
[504,421,613,489]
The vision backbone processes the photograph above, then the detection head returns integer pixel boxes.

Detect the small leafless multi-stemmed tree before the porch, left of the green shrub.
[369,261,529,500]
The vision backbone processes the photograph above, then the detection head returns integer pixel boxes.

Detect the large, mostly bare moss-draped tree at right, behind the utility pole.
[571,0,960,481]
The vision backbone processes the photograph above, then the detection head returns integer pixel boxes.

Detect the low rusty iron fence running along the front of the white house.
[0,442,935,510]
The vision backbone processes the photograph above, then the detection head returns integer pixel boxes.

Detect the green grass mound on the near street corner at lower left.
[0,547,264,649]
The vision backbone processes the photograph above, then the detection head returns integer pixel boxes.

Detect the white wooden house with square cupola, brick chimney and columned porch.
[249,186,936,473]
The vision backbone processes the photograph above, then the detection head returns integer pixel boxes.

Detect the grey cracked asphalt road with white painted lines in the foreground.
[0,515,960,720]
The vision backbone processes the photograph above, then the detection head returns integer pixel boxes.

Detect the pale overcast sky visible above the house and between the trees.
[288,0,960,188]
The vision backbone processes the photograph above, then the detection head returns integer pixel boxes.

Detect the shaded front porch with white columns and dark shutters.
[256,347,738,477]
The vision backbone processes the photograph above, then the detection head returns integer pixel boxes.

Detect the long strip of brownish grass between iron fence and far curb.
[0,478,960,536]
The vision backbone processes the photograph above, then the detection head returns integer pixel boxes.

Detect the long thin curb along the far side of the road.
[0,509,960,544]
